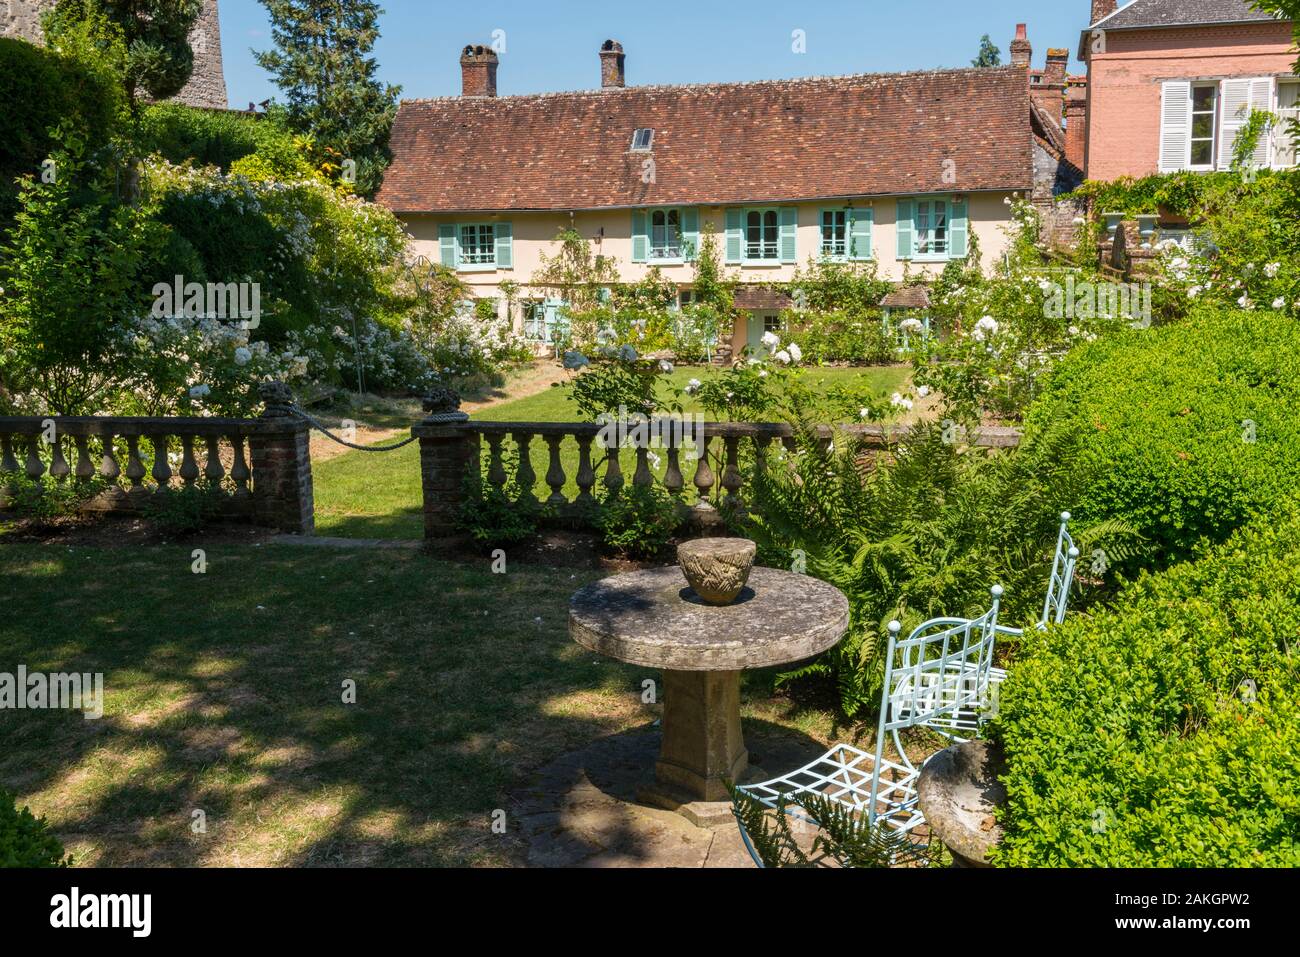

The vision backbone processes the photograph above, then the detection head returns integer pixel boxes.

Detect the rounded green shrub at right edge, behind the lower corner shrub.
[1028,309,1300,572]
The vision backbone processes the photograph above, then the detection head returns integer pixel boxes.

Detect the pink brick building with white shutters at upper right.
[1079,0,1300,179]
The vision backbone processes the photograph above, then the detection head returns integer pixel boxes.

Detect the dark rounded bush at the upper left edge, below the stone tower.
[0,33,126,226]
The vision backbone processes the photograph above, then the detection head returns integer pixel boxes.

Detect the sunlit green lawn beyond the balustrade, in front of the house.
[313,367,909,538]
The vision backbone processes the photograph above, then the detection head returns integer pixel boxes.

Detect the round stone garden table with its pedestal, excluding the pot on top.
[569,566,849,823]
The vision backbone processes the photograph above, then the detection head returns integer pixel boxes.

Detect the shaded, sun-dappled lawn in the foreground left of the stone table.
[0,545,842,866]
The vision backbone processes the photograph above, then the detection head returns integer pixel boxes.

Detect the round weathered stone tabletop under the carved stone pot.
[569,566,849,671]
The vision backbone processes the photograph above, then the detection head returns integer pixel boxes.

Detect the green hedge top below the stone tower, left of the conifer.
[137,103,312,179]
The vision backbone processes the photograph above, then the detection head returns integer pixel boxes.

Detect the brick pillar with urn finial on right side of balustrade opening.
[411,387,481,538]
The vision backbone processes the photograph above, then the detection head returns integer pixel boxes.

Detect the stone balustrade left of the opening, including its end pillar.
[0,392,315,534]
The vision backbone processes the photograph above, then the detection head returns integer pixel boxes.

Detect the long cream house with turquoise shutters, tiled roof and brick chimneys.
[377,32,1078,352]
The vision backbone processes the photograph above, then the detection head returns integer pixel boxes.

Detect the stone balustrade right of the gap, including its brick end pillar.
[412,416,1021,538]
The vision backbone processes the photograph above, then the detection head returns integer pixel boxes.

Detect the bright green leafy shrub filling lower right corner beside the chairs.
[992,506,1300,867]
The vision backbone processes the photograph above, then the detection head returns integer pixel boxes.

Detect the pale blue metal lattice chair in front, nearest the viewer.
[736,585,1002,866]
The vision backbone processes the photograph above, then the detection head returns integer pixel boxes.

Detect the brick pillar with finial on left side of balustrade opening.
[248,382,316,534]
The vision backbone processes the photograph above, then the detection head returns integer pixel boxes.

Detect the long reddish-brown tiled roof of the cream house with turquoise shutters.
[378,68,1032,212]
